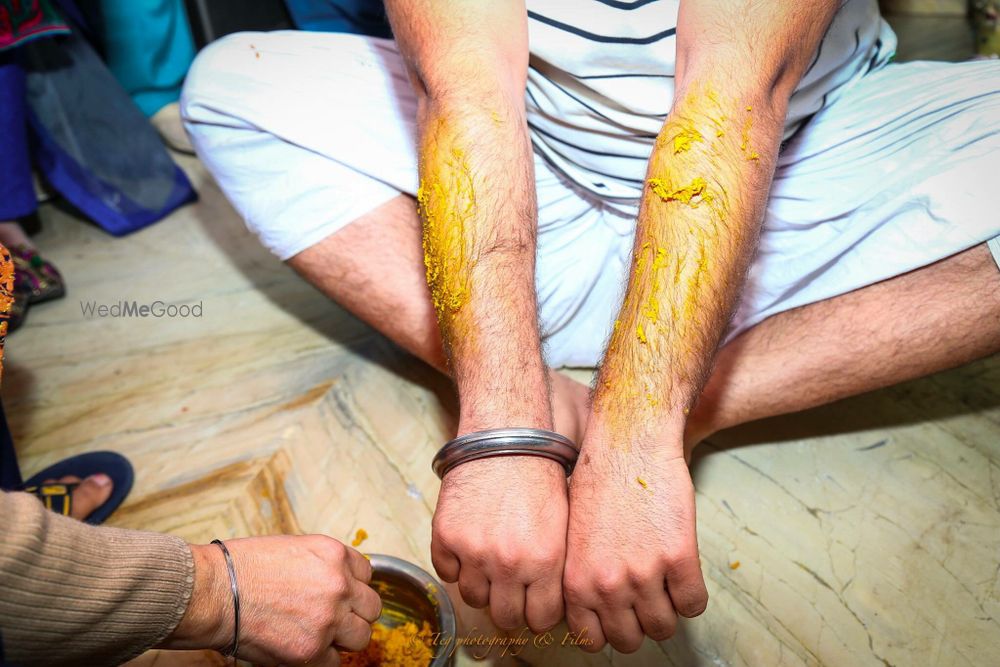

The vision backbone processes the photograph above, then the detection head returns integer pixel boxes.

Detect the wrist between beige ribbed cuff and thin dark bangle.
[162,544,234,650]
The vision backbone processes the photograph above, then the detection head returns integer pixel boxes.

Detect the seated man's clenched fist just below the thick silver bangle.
[431,456,568,632]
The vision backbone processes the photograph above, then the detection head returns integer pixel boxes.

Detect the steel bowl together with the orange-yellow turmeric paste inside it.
[341,554,456,667]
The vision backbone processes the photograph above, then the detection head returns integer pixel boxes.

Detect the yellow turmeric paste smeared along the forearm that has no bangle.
[594,88,759,422]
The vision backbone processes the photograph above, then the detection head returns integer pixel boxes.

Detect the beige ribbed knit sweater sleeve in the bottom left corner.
[0,493,194,666]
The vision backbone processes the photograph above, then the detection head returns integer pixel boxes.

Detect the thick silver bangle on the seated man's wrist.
[431,428,578,479]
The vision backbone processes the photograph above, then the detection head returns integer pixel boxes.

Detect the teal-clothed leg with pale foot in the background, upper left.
[80,0,195,152]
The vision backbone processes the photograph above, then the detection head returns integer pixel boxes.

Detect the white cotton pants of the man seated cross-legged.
[181,31,1000,367]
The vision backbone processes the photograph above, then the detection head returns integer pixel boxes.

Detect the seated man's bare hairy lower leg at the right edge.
[686,244,1000,453]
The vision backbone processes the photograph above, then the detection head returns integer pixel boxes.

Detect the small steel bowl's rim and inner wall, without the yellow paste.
[368,554,457,667]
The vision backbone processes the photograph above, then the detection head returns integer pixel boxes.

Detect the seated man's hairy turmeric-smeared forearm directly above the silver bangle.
[417,94,551,431]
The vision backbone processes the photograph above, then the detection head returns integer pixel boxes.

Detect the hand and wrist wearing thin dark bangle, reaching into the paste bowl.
[161,535,382,667]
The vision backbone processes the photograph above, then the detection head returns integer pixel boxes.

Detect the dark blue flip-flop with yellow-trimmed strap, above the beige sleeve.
[23,452,135,526]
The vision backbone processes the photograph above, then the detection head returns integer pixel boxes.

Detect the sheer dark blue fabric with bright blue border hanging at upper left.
[22,24,197,236]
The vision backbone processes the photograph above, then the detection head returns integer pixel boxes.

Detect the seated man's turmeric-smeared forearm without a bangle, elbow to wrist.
[594,85,784,447]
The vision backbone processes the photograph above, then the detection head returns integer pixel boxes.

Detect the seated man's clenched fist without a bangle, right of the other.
[563,429,708,653]
